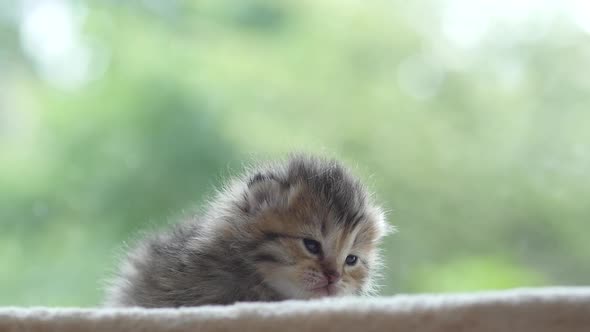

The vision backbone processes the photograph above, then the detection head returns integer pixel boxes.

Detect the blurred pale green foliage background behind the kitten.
[0,0,590,306]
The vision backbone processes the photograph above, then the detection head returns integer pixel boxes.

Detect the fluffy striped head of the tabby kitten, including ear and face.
[232,156,388,299]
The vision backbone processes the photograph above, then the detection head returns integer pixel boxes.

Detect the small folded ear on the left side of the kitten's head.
[245,173,298,212]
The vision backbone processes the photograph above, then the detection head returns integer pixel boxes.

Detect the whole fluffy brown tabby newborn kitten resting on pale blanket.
[107,156,388,307]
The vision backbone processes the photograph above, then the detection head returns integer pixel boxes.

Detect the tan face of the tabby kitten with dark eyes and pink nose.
[254,185,384,299]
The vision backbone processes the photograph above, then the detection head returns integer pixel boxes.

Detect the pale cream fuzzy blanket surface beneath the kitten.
[0,287,590,332]
